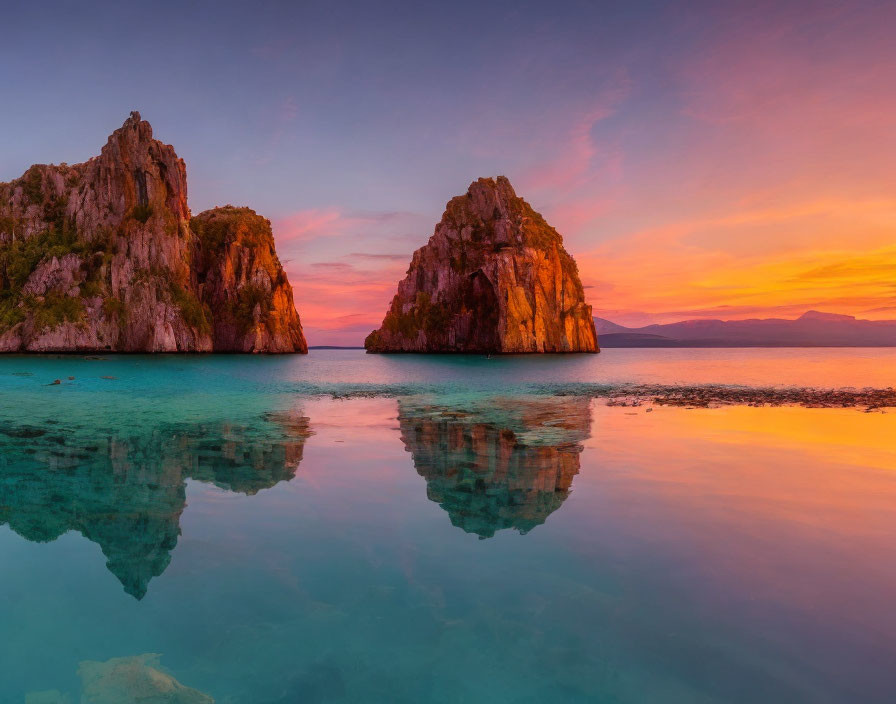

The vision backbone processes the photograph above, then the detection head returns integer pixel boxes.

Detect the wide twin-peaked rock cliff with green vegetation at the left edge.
[0,112,307,352]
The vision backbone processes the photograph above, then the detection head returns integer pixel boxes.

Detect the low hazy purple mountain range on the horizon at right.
[594,310,896,347]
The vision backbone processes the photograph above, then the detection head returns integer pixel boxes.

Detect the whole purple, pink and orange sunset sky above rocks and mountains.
[0,0,896,344]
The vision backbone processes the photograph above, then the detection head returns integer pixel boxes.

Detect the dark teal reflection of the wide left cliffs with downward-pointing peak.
[0,413,310,599]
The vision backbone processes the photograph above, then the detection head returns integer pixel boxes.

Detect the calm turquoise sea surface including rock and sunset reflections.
[0,350,896,704]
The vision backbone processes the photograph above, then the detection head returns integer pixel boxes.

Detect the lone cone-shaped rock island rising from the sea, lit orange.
[364,176,598,353]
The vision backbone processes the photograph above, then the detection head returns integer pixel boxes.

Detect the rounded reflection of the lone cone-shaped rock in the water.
[398,397,591,538]
